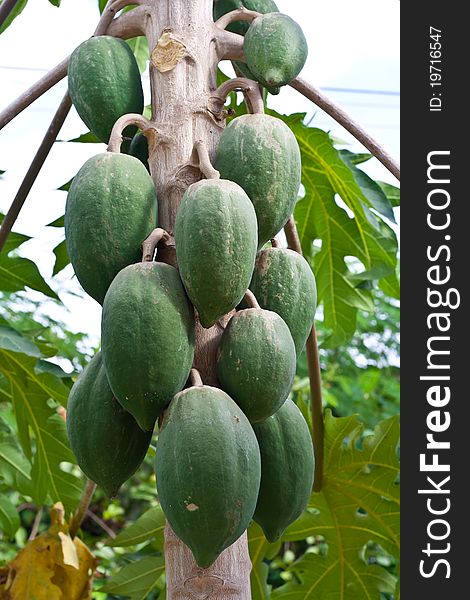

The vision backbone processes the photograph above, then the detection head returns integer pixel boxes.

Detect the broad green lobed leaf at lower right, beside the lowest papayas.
[272,412,400,600]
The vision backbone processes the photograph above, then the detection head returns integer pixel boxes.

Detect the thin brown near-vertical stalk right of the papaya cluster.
[284,216,325,492]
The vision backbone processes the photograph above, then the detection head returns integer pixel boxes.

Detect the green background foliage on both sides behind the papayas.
[0,0,399,600]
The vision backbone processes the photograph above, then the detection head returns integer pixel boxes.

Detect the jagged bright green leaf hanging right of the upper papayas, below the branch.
[284,115,398,347]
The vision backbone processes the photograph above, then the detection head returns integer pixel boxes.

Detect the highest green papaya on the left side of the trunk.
[68,35,144,144]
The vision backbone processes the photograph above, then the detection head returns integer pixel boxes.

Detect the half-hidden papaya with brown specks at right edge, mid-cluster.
[250,248,317,356]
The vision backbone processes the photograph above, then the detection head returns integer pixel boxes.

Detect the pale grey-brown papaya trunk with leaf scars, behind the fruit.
[145,0,251,600]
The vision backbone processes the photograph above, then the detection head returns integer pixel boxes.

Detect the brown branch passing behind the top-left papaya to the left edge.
[0,6,147,129]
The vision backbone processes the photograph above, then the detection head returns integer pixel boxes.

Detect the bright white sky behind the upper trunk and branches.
[0,0,400,356]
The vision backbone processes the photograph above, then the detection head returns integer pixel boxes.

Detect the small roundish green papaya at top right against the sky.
[243,12,308,94]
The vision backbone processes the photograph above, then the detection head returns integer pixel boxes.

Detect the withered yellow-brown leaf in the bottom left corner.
[0,504,96,600]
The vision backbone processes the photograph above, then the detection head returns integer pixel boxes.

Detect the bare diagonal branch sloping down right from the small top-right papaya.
[289,77,400,180]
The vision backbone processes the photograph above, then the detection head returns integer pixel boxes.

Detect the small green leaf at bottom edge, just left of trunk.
[100,556,165,600]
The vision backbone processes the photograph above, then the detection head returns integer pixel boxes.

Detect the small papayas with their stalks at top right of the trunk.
[213,0,308,94]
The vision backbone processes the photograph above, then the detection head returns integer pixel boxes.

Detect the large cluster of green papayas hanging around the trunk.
[65,13,316,568]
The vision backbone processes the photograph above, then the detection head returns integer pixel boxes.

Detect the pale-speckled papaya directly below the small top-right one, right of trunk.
[215,114,300,247]
